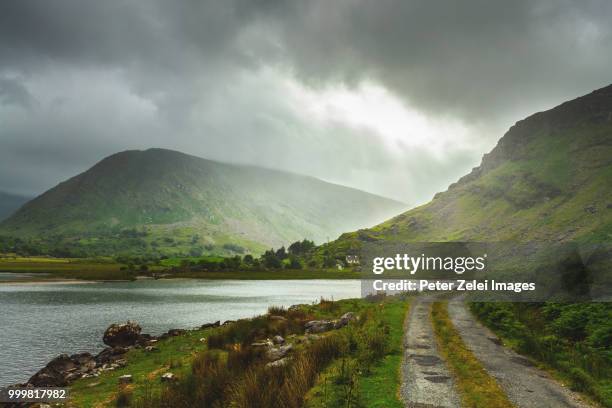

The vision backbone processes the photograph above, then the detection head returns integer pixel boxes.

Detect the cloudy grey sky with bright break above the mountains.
[0,0,612,205]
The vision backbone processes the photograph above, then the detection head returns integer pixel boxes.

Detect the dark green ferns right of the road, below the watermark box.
[471,303,612,407]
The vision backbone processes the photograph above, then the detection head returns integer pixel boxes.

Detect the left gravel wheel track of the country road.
[400,296,460,408]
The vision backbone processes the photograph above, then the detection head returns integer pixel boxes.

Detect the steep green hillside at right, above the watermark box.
[331,85,612,254]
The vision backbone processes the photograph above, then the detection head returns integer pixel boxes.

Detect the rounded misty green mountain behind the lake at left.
[0,149,405,254]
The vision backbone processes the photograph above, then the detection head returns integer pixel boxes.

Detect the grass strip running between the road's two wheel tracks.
[431,302,514,408]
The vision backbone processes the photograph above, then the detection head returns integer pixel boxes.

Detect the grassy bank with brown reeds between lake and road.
[69,297,407,408]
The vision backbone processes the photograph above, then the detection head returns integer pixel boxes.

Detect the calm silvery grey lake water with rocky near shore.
[0,274,360,386]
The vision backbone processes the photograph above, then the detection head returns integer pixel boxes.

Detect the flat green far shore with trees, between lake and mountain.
[0,239,360,280]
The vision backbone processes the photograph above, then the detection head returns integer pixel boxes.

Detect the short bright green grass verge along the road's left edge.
[305,297,410,408]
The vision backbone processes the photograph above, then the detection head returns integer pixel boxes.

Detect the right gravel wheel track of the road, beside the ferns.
[448,298,593,408]
